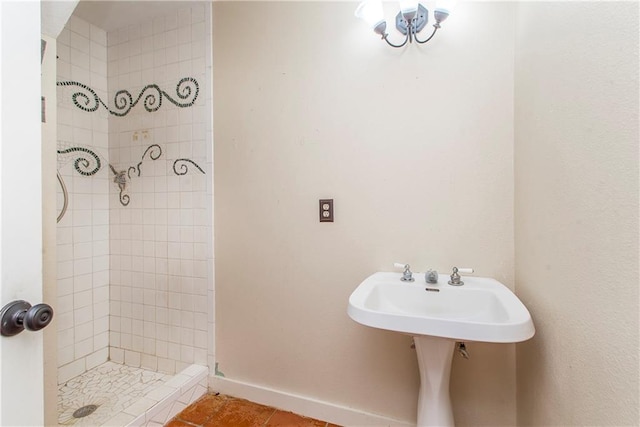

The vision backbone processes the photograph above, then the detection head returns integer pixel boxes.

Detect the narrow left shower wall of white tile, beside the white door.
[56,16,110,383]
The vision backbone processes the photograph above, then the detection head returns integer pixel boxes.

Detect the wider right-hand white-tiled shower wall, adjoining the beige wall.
[107,3,213,373]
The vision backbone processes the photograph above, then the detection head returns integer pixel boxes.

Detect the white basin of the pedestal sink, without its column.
[347,273,535,343]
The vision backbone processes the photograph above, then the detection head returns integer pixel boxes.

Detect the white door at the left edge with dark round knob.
[0,0,44,426]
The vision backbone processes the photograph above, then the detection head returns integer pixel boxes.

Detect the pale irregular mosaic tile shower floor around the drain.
[58,362,172,426]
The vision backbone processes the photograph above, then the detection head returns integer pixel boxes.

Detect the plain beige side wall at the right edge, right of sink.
[515,2,639,426]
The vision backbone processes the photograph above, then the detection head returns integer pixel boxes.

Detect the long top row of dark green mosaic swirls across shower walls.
[56,77,200,117]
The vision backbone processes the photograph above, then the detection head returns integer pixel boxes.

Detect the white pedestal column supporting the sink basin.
[413,335,455,427]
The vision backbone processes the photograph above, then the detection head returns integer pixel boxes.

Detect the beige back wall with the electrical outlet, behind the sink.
[213,2,515,425]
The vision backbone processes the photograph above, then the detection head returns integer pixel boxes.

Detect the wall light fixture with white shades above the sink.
[355,0,454,47]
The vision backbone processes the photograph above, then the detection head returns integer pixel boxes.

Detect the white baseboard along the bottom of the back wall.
[209,376,415,427]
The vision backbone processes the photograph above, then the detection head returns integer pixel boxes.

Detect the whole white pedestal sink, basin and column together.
[347,272,535,427]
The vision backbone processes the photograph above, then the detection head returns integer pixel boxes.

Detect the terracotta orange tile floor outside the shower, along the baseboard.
[165,393,338,427]
